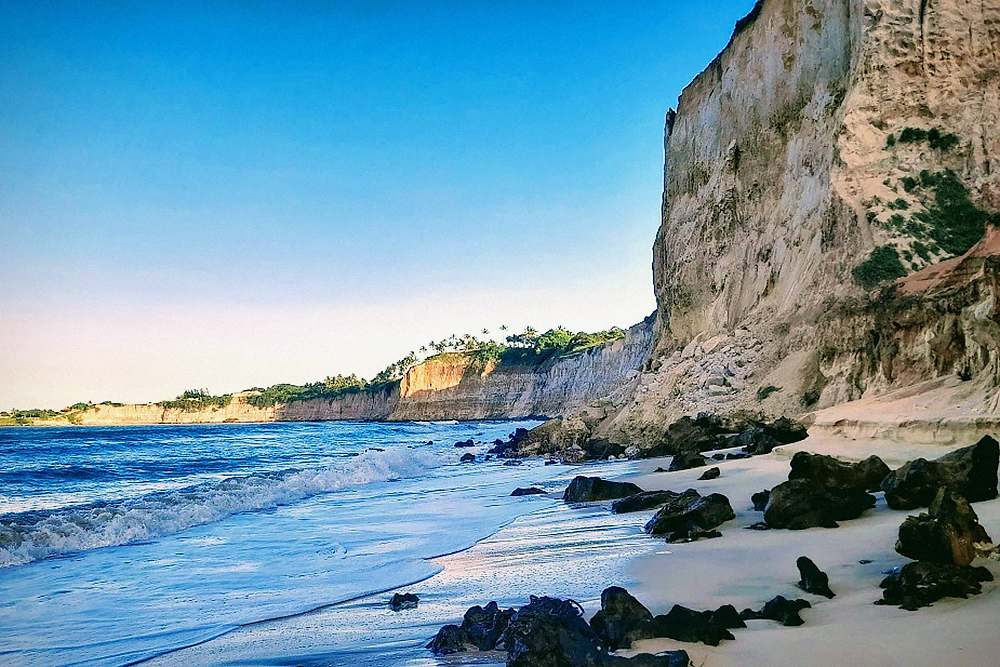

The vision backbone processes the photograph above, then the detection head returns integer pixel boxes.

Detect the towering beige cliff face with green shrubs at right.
[597,0,1000,443]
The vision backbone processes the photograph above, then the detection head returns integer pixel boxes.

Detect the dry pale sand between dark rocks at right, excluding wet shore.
[623,434,1000,667]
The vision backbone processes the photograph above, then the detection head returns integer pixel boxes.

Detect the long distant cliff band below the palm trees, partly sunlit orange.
[76,317,655,425]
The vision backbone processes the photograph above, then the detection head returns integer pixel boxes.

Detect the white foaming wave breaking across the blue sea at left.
[0,448,439,567]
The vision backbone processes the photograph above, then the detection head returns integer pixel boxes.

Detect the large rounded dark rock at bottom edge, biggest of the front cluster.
[503,595,607,667]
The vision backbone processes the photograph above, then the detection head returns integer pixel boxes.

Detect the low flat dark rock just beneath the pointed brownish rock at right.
[875,562,993,611]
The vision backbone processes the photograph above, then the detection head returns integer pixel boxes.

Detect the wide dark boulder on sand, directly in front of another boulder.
[764,479,875,530]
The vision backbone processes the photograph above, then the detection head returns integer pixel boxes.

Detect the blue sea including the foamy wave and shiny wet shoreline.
[0,421,647,666]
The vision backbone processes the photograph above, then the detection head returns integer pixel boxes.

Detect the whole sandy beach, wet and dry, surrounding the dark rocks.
[149,433,1000,667]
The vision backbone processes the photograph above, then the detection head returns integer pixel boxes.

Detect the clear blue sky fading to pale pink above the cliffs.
[0,0,753,410]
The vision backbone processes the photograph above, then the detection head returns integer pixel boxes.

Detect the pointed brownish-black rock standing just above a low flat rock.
[896,487,990,565]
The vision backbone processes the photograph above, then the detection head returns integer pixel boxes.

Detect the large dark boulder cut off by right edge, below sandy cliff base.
[882,435,1000,510]
